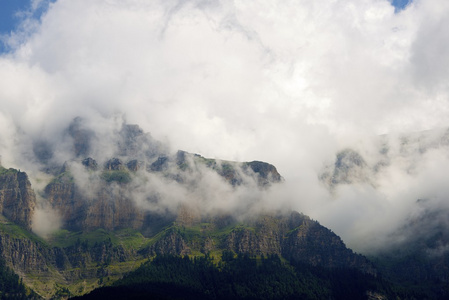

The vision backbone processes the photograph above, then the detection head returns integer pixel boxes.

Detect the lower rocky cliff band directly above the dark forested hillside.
[141,212,376,274]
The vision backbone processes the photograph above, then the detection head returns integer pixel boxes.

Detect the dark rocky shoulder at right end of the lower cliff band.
[218,212,375,273]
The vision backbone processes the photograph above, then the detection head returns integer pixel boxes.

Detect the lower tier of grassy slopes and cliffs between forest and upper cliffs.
[0,173,377,297]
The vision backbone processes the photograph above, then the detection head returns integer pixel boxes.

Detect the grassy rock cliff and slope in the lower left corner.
[0,224,141,299]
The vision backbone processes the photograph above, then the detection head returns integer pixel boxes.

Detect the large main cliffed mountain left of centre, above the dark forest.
[0,118,384,298]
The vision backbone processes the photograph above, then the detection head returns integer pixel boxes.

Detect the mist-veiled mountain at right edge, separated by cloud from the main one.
[319,130,449,299]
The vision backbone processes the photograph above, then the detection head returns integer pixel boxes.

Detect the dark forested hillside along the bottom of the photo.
[74,252,394,299]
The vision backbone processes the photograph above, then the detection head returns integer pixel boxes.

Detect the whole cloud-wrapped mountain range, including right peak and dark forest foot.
[0,118,449,299]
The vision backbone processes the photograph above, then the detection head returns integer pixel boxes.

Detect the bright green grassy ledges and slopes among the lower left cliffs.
[0,203,266,298]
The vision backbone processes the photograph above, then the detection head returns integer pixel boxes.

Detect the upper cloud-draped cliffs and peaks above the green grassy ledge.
[35,118,282,232]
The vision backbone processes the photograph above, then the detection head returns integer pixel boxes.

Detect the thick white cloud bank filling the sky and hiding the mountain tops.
[0,0,449,251]
